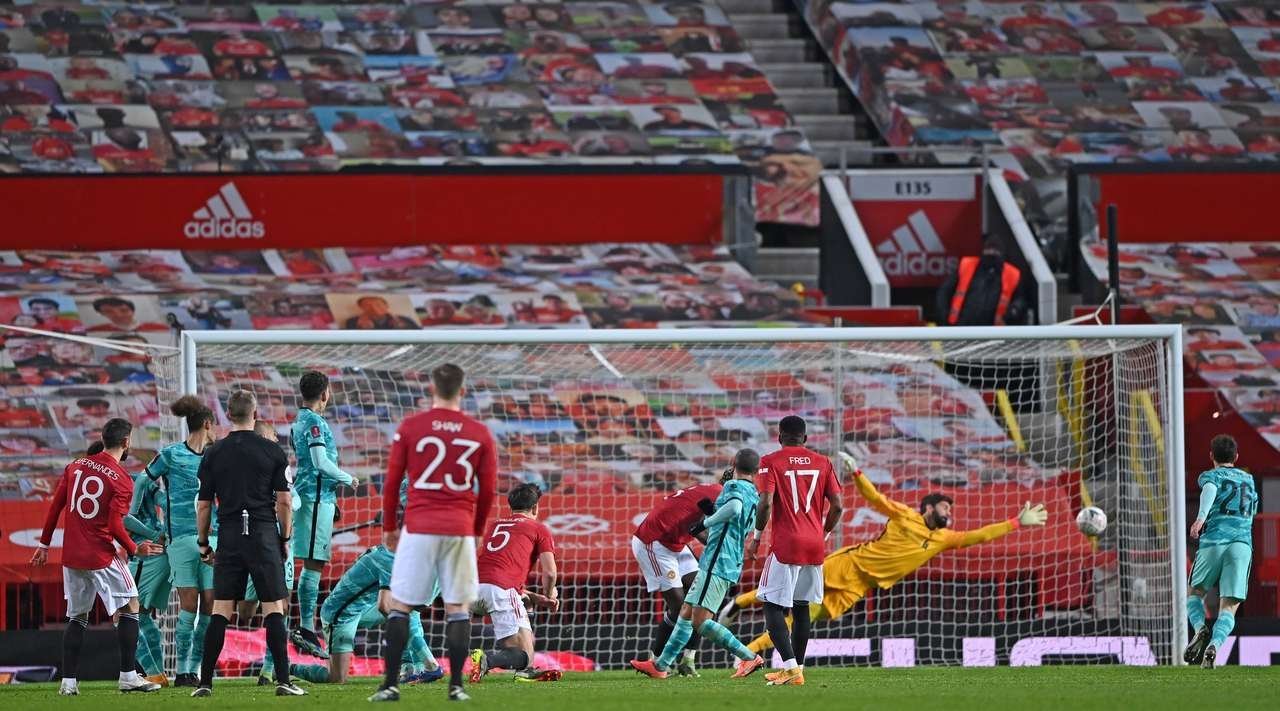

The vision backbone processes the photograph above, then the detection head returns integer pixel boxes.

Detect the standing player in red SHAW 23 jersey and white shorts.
[369,363,498,701]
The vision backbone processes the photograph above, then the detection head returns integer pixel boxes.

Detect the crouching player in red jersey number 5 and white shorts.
[471,484,561,684]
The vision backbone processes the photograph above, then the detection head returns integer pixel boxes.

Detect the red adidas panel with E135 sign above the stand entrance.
[849,169,982,287]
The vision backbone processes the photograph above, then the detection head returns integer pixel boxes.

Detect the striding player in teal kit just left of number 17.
[631,450,764,679]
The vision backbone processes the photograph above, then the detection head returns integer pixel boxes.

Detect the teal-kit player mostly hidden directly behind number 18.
[122,453,172,687]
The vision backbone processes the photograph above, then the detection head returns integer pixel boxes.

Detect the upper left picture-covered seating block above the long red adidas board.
[0,0,817,224]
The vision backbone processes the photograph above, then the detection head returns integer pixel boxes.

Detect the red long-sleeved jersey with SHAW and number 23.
[383,407,498,535]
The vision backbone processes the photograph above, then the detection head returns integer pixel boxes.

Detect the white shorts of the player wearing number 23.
[392,529,480,607]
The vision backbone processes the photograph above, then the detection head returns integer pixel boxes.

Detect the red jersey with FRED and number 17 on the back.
[756,447,840,565]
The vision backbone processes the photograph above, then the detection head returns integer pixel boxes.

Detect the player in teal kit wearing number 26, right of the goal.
[1183,434,1258,669]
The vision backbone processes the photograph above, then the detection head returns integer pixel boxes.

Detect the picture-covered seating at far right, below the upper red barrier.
[1082,242,1280,451]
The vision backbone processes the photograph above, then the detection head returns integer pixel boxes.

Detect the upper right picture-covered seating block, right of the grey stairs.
[803,0,1280,231]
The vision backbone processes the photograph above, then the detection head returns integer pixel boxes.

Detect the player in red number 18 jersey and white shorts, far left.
[31,418,164,696]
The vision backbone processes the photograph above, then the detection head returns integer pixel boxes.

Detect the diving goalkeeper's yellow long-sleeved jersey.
[823,474,1016,589]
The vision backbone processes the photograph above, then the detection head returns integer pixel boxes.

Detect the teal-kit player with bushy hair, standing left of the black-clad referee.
[146,395,214,687]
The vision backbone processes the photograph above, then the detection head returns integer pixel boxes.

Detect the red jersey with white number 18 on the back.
[40,452,137,570]
